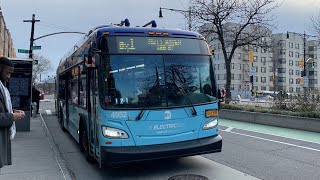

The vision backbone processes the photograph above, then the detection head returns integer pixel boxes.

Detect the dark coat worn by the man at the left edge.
[0,93,13,168]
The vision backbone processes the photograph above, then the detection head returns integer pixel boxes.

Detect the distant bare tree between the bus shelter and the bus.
[32,54,52,82]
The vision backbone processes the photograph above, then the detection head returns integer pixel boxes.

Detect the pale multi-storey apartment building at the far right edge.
[272,32,320,93]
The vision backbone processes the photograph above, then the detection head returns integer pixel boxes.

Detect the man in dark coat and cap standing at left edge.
[0,57,25,170]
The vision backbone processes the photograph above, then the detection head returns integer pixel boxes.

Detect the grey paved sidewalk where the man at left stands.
[0,114,72,180]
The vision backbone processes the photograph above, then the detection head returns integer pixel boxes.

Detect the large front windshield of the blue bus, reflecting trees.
[99,54,217,109]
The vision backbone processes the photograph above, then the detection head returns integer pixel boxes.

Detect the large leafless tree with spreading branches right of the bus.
[191,0,278,99]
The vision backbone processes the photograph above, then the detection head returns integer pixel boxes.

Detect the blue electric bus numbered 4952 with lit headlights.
[56,20,222,165]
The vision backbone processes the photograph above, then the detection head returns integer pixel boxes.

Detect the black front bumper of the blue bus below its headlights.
[101,135,222,164]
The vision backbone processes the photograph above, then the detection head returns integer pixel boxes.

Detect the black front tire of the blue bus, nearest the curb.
[79,121,94,163]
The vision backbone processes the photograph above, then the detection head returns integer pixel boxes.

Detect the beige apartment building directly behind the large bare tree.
[202,23,274,98]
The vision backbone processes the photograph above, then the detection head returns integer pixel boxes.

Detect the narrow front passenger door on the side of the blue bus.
[87,69,99,155]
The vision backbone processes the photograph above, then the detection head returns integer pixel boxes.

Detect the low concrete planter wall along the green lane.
[219,109,320,132]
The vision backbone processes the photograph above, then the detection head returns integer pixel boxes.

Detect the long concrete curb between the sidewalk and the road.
[39,114,76,180]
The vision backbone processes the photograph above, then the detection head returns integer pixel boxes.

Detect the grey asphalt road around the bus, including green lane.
[40,97,320,180]
